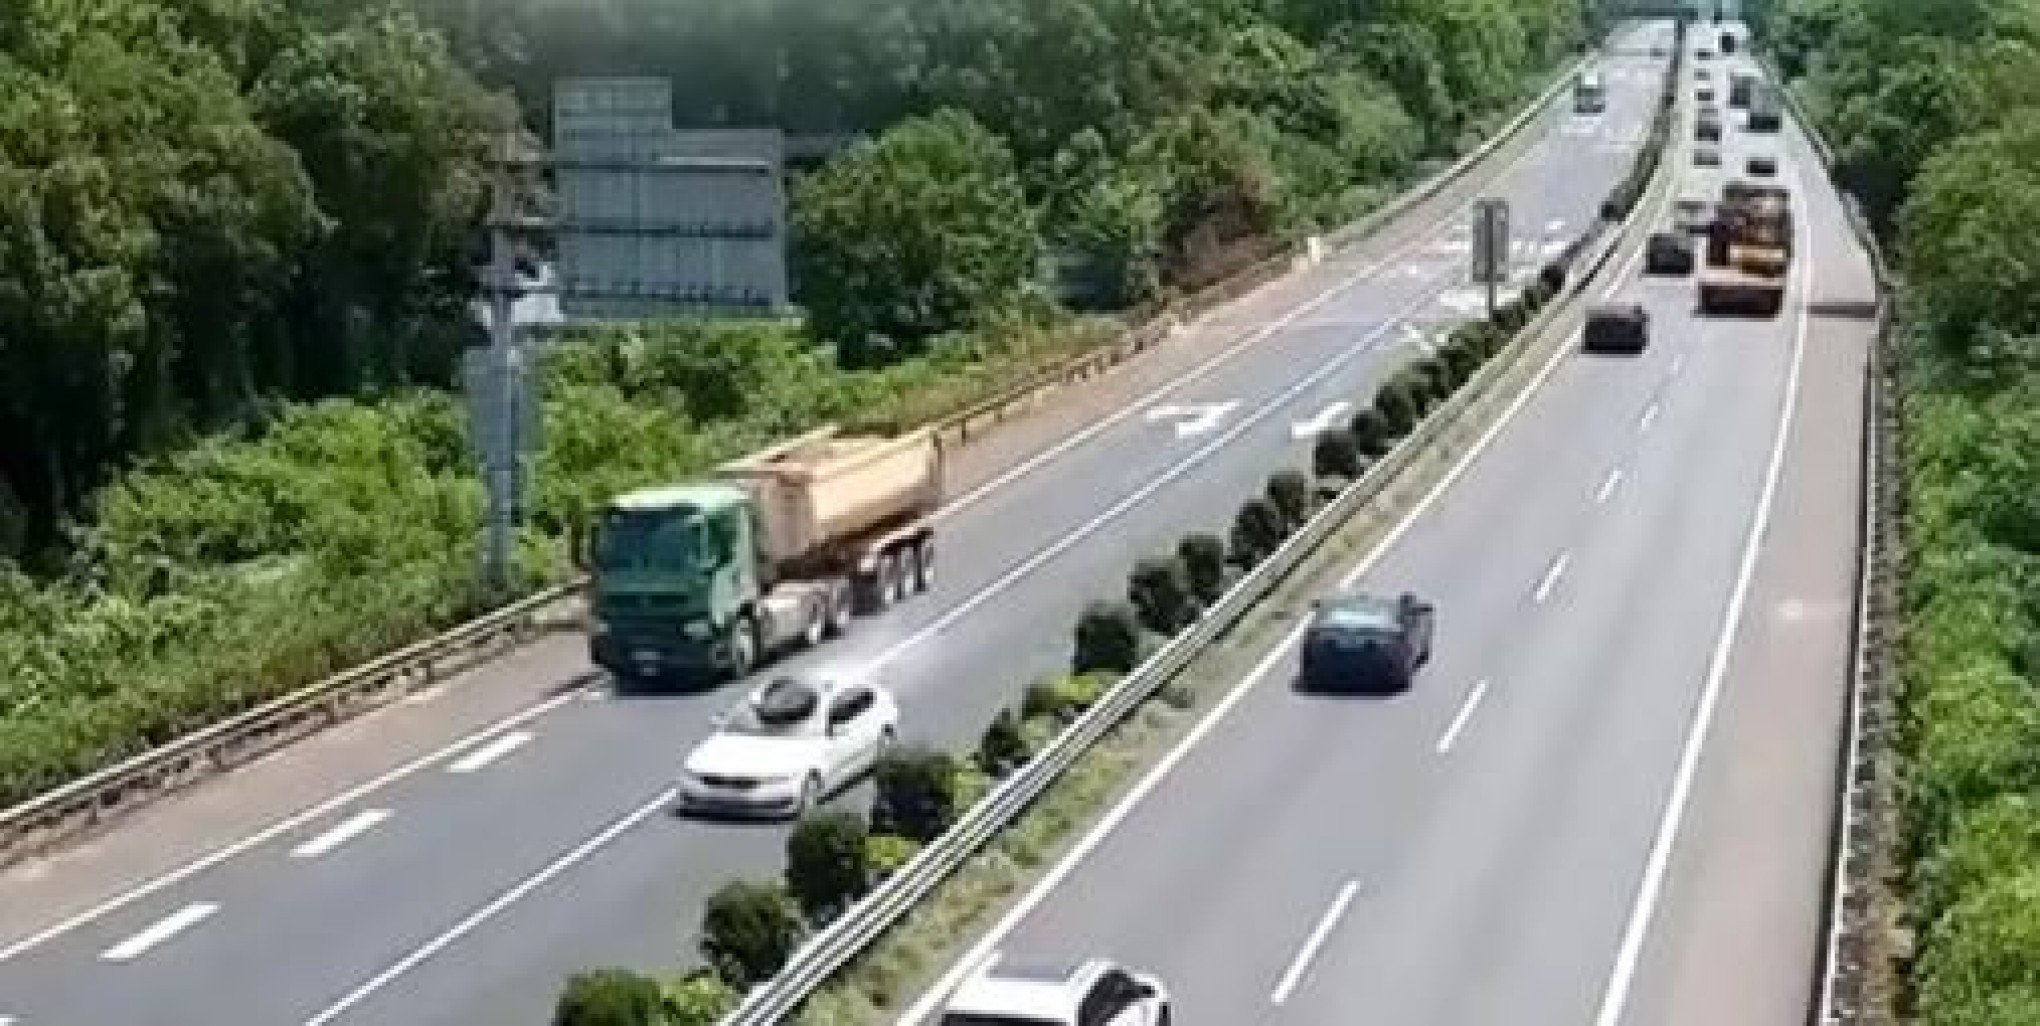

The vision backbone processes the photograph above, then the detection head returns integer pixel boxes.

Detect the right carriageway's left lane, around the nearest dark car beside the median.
[958,265,1721,1022]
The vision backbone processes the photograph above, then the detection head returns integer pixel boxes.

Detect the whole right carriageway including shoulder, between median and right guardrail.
[902,30,1875,1026]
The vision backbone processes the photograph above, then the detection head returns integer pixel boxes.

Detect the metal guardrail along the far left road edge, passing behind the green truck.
[0,44,1589,867]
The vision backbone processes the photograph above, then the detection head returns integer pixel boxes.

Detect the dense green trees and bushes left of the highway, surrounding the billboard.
[0,0,1587,806]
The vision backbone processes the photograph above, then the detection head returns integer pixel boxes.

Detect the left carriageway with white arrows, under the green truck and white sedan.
[0,18,1669,1026]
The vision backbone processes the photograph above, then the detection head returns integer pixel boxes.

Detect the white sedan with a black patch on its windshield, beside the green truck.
[679,677,900,816]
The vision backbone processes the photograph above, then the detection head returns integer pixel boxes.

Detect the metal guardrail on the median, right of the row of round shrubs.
[722,138,1665,1026]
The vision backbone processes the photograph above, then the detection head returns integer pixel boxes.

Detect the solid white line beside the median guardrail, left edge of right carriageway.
[898,279,1579,1026]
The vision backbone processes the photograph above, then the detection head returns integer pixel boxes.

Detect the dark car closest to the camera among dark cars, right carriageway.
[1302,589,1438,691]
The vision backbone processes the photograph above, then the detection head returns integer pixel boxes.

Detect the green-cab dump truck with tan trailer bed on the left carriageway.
[588,426,942,679]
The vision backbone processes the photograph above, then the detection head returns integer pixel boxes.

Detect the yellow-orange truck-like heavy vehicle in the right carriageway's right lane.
[1699,179,1793,316]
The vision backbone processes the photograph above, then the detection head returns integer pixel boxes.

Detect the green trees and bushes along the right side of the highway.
[1763,0,2040,1026]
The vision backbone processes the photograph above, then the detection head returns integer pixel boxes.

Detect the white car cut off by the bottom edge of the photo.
[936,959,1171,1026]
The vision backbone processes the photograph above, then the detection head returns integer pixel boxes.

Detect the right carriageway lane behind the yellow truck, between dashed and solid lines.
[1285,283,1781,1026]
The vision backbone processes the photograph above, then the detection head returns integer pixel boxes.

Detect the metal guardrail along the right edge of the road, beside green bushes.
[1758,57,1899,1026]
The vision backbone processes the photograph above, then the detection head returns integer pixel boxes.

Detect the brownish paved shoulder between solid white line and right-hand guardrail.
[1630,131,1877,1024]
